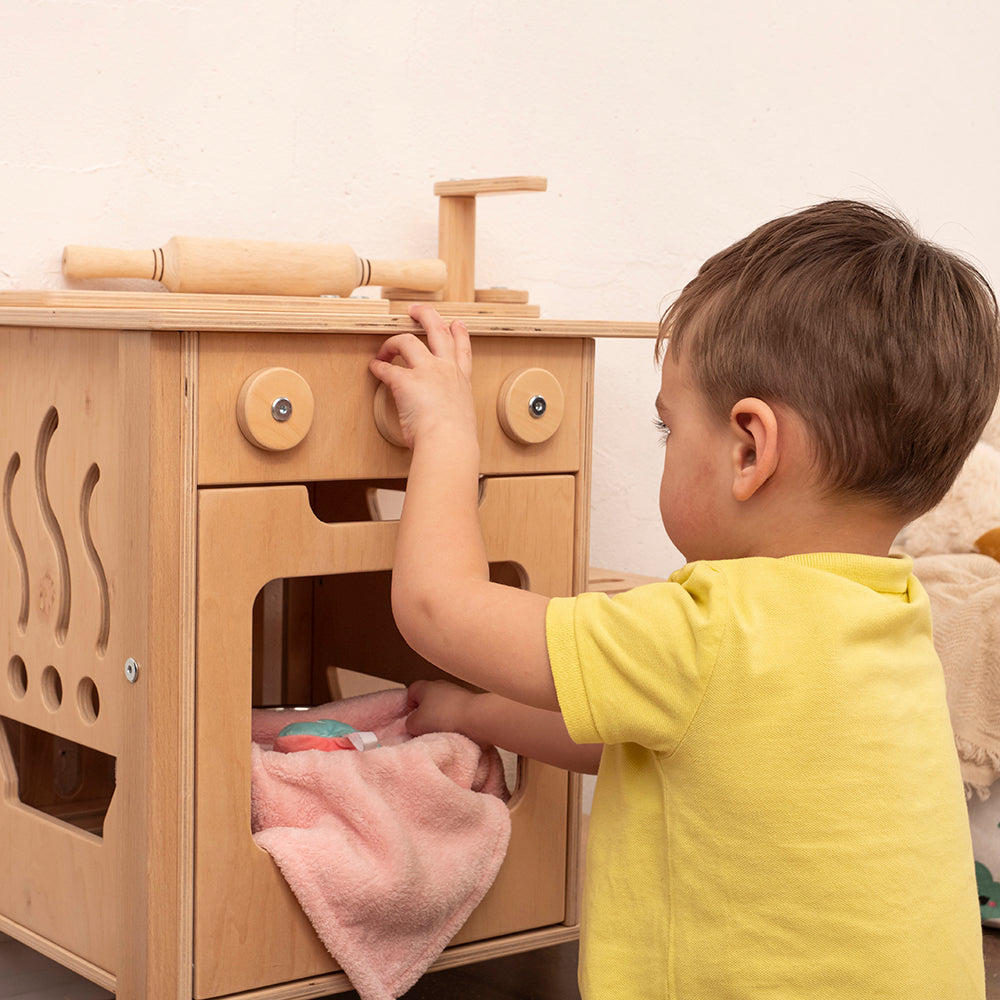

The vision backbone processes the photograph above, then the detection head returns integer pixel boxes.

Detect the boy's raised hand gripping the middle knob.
[369,303,476,448]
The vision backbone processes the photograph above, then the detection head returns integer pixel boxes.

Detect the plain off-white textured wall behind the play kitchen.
[0,0,1000,574]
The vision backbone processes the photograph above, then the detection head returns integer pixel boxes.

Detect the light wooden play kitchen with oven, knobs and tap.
[0,178,655,1000]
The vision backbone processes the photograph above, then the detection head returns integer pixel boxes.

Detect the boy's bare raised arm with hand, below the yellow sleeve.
[370,305,558,709]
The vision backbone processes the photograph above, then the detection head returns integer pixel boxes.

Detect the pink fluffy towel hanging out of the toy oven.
[252,690,510,1000]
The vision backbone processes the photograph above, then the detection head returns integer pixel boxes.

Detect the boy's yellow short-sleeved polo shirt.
[546,554,984,1000]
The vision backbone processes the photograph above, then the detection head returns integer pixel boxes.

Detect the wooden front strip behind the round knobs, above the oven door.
[198,333,592,485]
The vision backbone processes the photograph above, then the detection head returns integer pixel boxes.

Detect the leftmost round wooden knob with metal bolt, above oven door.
[236,368,314,451]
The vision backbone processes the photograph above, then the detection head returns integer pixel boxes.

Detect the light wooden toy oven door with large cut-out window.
[195,476,575,996]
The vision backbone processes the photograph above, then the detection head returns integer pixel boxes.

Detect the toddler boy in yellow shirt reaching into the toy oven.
[371,201,1000,1000]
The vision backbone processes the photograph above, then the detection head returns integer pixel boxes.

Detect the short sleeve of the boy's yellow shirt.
[545,563,730,754]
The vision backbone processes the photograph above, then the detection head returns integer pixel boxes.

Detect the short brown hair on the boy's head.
[657,201,1000,518]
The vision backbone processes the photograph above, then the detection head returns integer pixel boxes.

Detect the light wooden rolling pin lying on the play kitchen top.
[63,236,447,296]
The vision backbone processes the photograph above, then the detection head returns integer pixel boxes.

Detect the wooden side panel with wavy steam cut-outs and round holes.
[0,328,136,976]
